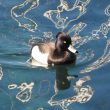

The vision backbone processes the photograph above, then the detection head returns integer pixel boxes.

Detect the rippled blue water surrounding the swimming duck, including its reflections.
[0,0,110,110]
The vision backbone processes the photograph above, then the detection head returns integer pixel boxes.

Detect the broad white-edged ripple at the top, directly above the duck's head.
[44,0,90,29]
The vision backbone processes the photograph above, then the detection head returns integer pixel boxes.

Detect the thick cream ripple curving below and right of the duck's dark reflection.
[48,76,94,110]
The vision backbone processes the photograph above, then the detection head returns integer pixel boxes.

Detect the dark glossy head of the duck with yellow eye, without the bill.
[55,32,72,51]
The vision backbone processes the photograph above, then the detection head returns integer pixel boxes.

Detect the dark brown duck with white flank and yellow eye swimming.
[30,32,78,66]
